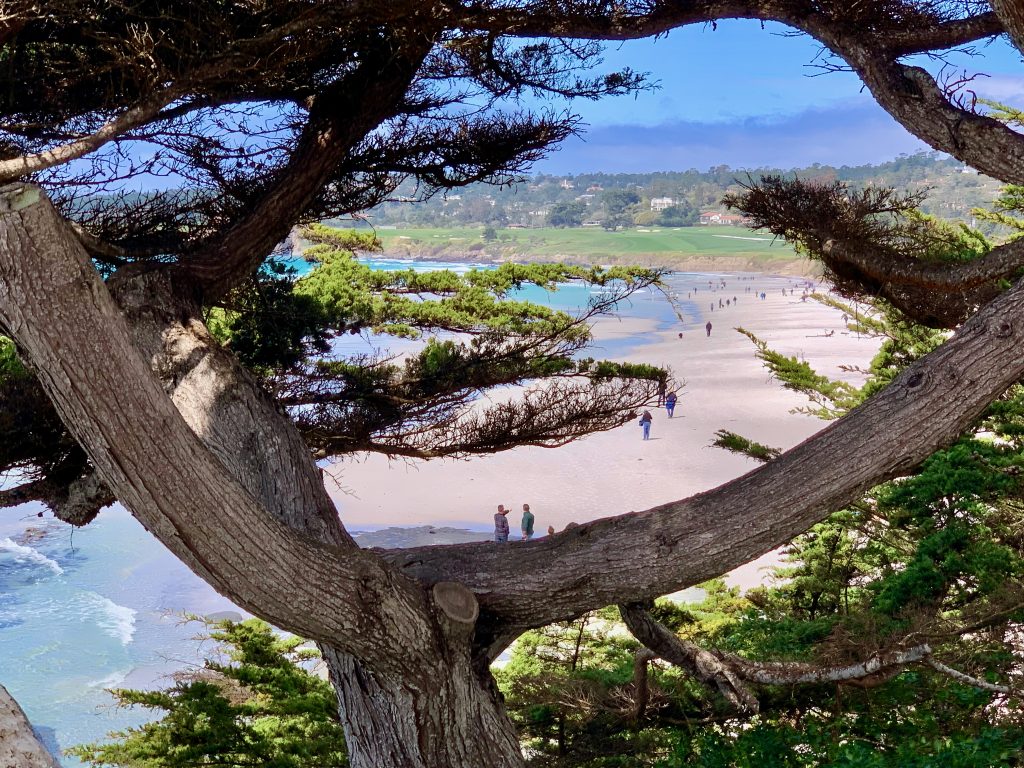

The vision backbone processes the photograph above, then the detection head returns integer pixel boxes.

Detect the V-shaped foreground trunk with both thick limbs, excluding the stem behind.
[6,173,1024,768]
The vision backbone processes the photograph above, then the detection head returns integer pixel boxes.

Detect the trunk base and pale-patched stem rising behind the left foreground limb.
[108,272,521,768]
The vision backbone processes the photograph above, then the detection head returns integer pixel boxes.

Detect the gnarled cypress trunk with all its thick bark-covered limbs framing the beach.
[6,0,1024,768]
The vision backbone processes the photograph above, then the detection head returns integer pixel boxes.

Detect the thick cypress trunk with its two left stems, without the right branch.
[0,187,522,768]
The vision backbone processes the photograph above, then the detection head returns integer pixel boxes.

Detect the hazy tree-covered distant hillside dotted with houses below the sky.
[358,153,1000,233]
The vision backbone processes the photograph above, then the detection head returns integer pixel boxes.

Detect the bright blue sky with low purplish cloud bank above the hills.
[535,20,1024,174]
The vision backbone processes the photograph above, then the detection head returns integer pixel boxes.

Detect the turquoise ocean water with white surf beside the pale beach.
[0,259,770,766]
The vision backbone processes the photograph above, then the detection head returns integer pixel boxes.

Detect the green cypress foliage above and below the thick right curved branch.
[489,290,1024,768]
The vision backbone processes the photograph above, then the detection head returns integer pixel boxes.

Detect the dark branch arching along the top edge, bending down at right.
[465,0,1024,183]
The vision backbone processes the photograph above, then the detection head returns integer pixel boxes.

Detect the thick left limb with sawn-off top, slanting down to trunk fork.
[0,185,435,677]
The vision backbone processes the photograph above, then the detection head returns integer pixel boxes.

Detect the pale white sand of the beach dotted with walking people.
[329,275,879,584]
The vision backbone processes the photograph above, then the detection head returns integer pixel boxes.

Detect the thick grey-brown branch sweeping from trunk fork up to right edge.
[386,270,1024,645]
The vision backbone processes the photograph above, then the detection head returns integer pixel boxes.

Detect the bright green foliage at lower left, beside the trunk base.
[68,618,348,768]
